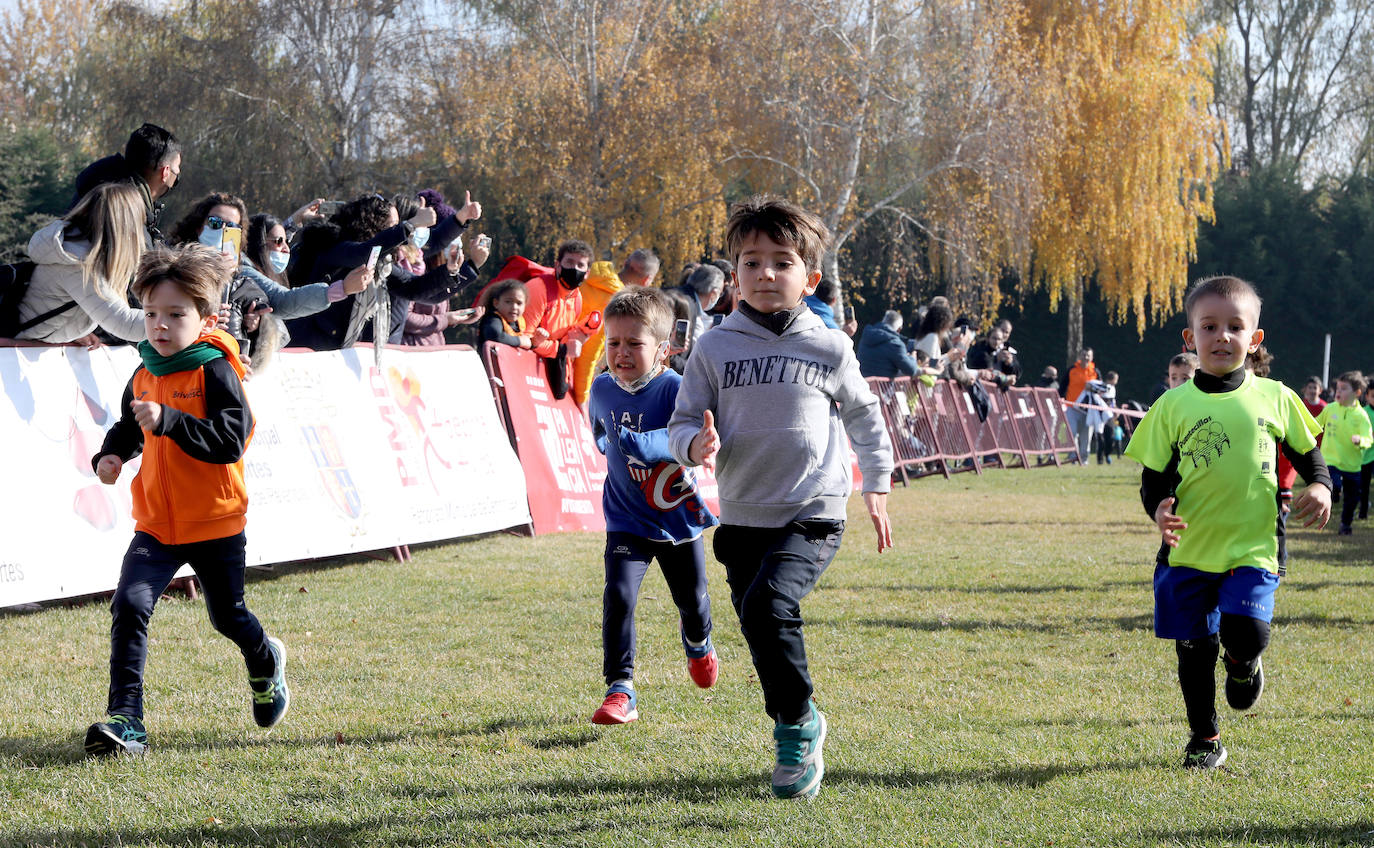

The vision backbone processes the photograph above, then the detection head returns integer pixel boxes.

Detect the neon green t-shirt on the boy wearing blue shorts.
[1125,374,1320,573]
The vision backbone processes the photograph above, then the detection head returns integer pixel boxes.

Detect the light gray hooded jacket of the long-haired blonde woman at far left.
[19,219,147,345]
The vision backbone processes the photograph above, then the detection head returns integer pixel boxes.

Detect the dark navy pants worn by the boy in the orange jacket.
[109,532,276,719]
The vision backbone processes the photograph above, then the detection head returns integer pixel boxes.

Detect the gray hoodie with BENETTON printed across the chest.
[668,303,893,526]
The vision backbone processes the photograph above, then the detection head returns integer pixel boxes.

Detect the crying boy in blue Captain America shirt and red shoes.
[588,286,719,724]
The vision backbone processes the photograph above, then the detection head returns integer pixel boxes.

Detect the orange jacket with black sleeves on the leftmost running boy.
[91,330,254,544]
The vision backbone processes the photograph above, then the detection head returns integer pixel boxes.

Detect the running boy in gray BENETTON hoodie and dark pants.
[668,197,893,799]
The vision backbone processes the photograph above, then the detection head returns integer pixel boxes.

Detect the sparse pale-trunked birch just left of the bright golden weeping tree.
[725,0,1041,318]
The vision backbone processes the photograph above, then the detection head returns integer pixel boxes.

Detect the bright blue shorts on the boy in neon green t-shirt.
[1154,562,1279,639]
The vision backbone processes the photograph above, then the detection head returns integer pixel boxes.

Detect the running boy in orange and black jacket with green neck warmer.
[85,245,290,756]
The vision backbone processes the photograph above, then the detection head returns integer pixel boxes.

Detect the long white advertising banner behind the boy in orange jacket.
[0,348,530,606]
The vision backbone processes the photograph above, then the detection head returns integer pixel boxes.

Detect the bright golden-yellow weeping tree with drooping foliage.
[1025,0,1221,361]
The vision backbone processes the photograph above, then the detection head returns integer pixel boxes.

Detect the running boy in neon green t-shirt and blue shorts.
[1125,276,1331,768]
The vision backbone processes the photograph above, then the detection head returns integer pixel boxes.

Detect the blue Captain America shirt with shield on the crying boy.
[587,370,720,544]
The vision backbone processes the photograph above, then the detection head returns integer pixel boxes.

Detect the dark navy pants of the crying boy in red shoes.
[602,532,710,686]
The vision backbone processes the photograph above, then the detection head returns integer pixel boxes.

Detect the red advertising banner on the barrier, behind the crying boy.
[486,345,606,533]
